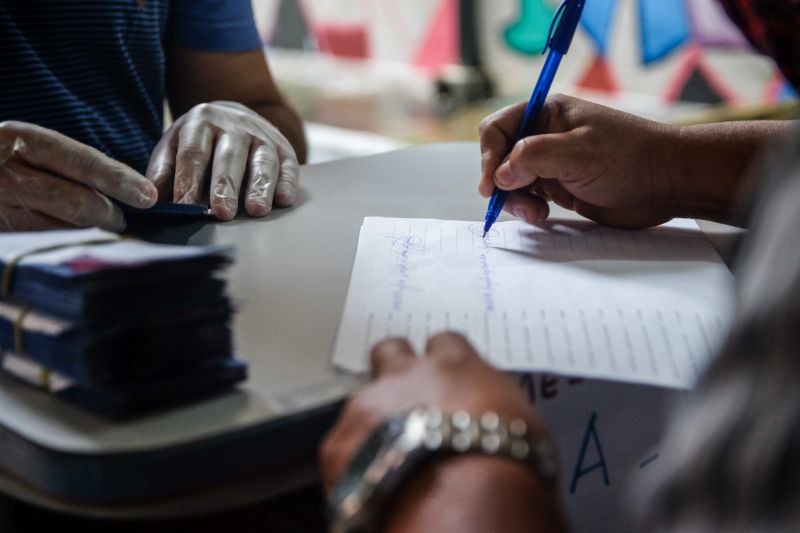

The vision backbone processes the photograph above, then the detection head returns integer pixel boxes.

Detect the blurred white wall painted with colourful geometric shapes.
[253,0,796,105]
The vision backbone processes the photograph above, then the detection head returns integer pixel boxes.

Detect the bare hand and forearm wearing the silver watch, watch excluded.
[320,333,566,533]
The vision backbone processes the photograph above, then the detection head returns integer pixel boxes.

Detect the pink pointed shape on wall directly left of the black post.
[414,0,459,74]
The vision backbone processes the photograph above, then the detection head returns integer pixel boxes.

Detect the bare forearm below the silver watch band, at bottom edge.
[385,455,567,533]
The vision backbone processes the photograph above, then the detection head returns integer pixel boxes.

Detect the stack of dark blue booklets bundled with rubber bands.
[0,229,247,417]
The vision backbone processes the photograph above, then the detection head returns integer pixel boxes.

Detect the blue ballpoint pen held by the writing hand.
[483,0,586,237]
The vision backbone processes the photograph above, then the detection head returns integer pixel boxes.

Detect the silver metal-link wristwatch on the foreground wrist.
[328,407,557,533]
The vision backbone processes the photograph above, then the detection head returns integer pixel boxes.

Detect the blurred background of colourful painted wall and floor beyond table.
[253,0,798,161]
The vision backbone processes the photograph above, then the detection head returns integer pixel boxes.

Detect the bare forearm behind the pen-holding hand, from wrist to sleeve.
[662,121,797,222]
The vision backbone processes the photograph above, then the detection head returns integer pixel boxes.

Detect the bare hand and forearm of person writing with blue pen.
[479,95,791,228]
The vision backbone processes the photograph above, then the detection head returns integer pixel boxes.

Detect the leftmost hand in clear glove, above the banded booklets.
[0,121,157,231]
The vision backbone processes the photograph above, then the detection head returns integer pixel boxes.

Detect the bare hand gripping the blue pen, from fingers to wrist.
[479,95,679,228]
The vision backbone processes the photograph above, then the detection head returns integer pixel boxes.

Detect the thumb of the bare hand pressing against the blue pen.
[494,133,578,191]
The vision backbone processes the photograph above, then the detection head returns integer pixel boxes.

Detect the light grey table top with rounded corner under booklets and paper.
[0,143,730,512]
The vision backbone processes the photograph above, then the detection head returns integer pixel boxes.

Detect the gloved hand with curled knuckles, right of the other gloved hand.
[147,102,300,220]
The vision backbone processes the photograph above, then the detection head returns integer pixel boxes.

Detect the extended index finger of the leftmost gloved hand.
[3,122,158,208]
